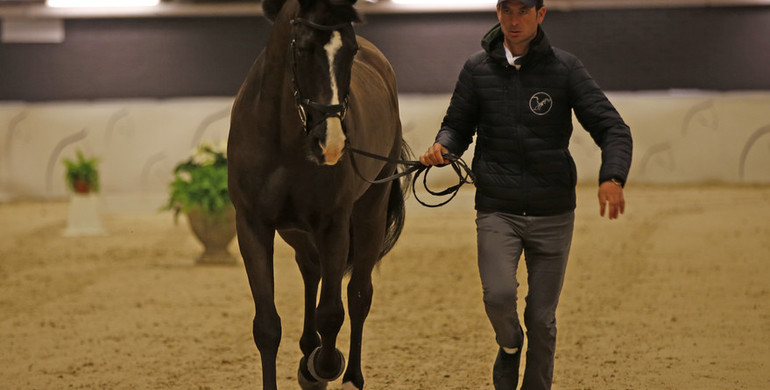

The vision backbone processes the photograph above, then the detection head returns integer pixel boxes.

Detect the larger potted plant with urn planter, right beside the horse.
[164,142,235,264]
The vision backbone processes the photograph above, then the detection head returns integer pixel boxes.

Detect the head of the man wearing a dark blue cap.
[497,0,545,55]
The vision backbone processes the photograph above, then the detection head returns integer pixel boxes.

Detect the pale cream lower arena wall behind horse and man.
[0,91,770,211]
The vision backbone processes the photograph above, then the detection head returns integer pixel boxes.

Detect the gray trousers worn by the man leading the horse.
[476,212,575,390]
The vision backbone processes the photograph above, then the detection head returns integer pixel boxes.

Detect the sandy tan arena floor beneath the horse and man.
[0,186,770,390]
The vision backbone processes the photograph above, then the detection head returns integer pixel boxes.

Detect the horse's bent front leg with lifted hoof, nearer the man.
[308,212,350,382]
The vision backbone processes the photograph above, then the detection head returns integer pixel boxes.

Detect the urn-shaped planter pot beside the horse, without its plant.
[187,207,236,264]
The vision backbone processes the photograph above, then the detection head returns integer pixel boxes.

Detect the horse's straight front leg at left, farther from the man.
[236,211,281,390]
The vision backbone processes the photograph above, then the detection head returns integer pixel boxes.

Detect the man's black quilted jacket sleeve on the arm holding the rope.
[436,53,481,156]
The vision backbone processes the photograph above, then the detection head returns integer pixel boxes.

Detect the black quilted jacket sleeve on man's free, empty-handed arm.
[569,57,633,184]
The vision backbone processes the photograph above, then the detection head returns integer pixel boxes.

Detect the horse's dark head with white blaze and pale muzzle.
[290,0,359,165]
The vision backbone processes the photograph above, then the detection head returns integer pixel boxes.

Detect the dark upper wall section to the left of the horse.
[0,18,269,101]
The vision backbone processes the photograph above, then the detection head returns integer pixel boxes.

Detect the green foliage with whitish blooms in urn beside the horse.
[163,142,232,220]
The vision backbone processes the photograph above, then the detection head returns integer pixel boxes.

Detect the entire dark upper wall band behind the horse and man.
[0,7,770,101]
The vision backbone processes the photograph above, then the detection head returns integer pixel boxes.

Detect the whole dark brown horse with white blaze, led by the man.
[228,0,408,389]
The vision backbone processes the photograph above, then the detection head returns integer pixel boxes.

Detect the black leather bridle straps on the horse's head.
[289,18,358,134]
